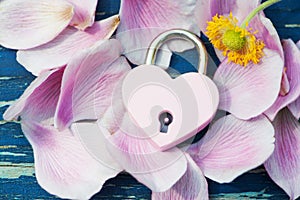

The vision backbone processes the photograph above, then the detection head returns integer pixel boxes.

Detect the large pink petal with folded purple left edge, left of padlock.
[55,40,130,129]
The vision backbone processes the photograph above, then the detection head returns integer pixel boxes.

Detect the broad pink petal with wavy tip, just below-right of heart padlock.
[188,115,274,183]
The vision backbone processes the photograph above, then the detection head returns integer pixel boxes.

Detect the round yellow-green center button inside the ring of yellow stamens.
[222,30,246,51]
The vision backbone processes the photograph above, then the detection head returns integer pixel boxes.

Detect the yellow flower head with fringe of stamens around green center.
[206,13,265,66]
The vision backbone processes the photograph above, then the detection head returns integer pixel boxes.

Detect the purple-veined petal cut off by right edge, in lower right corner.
[265,109,300,199]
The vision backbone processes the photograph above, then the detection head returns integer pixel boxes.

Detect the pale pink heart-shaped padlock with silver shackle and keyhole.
[122,30,219,150]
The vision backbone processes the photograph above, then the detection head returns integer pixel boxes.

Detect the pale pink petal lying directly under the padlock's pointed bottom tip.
[100,112,187,192]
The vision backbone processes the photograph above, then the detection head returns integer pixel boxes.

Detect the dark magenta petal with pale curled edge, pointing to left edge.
[3,67,65,121]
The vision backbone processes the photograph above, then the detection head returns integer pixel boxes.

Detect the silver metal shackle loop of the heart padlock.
[145,29,207,74]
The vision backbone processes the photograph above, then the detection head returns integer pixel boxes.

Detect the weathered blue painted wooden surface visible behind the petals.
[0,0,300,200]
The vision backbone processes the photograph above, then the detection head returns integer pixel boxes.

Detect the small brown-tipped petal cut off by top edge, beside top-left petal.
[67,0,98,30]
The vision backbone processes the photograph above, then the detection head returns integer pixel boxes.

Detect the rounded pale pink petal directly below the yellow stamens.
[214,49,283,119]
